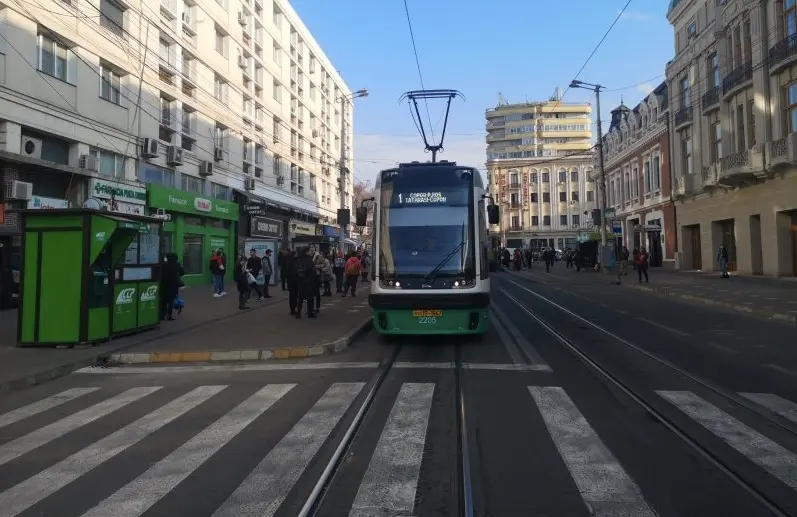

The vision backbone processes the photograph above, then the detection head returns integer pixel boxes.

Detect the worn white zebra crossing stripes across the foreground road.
[0,382,797,517]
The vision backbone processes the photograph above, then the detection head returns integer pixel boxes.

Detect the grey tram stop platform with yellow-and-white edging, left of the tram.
[109,292,371,364]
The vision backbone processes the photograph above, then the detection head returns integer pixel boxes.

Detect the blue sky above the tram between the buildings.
[291,0,673,185]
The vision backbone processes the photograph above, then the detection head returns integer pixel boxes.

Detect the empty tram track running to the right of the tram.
[502,280,797,517]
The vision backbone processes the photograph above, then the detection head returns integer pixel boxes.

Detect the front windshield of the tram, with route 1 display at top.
[379,171,475,278]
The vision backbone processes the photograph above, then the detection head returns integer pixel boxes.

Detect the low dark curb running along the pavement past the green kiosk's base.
[0,299,283,395]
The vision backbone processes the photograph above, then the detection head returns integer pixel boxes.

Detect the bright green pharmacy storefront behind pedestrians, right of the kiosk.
[147,184,238,285]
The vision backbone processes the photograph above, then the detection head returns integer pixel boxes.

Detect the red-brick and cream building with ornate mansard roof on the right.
[603,82,677,268]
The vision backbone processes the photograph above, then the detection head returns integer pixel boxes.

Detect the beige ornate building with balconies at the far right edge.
[667,0,797,276]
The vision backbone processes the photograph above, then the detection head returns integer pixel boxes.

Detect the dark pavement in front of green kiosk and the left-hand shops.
[0,286,364,394]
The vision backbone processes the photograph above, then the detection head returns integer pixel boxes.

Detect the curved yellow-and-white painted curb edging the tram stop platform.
[100,316,373,367]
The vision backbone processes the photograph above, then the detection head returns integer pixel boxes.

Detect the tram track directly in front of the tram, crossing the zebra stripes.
[296,338,475,517]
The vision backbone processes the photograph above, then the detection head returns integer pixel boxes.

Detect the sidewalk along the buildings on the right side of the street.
[510,264,797,323]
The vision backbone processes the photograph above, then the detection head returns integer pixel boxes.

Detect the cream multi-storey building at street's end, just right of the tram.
[486,96,596,249]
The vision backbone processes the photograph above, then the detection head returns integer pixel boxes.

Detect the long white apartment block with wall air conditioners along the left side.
[0,0,353,286]
